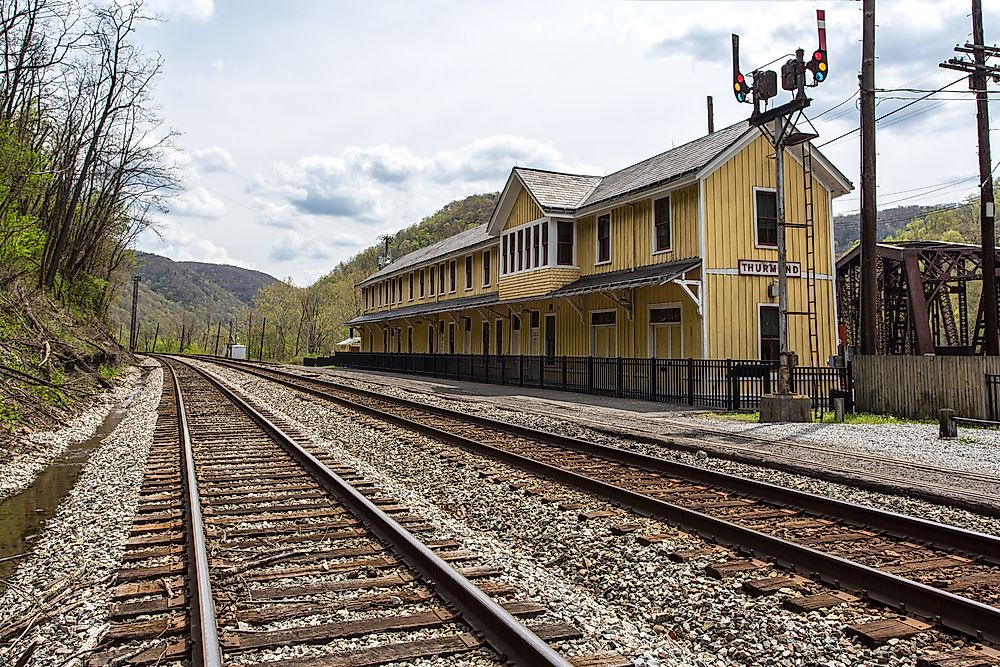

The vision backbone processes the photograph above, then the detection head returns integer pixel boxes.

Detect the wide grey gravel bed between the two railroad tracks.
[197,362,984,667]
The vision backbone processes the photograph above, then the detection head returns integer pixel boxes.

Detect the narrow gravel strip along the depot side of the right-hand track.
[284,372,1000,535]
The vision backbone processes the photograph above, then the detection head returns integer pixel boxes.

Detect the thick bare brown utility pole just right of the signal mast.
[859,0,879,354]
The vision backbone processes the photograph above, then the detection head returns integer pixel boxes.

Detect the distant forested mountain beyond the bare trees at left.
[108,252,277,350]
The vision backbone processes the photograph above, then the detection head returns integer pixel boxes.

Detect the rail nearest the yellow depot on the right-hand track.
[199,364,1000,565]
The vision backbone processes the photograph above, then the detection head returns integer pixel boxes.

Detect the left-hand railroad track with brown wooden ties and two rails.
[89,360,631,667]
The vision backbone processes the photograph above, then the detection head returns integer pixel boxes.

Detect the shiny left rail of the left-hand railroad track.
[164,364,224,667]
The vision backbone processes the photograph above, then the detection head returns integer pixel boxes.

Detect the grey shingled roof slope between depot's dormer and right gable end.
[579,120,752,208]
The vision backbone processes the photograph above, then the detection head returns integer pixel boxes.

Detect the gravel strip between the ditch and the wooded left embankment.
[0,367,140,499]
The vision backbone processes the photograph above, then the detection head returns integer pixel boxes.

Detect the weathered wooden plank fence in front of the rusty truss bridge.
[854,356,1000,419]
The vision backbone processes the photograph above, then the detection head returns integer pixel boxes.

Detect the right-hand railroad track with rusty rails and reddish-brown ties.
[197,363,1000,644]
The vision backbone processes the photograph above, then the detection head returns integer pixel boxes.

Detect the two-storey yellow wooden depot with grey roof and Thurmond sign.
[347,121,852,364]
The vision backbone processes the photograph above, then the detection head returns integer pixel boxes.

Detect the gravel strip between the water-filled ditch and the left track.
[0,368,163,667]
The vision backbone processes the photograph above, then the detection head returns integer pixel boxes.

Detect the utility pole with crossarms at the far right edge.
[941,0,1000,356]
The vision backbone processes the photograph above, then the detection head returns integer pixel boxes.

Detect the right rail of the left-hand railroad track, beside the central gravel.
[167,362,572,667]
